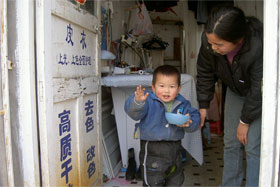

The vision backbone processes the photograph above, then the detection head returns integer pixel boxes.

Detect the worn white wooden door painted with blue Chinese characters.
[36,0,102,186]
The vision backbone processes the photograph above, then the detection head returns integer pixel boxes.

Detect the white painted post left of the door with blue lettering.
[8,0,40,186]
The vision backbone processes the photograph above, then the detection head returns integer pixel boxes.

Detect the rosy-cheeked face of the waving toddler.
[152,74,181,103]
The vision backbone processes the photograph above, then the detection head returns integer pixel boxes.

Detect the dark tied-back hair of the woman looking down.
[205,6,263,43]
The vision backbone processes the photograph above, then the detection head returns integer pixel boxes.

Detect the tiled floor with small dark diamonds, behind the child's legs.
[104,136,223,187]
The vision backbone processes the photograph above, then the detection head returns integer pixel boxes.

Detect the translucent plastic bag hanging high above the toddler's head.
[129,3,153,35]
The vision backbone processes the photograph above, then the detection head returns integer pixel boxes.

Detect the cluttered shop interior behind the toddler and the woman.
[101,0,263,186]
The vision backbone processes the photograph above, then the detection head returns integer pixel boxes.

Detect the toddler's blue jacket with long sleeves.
[124,91,200,141]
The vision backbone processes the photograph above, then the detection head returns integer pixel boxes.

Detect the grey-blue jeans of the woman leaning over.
[222,88,261,186]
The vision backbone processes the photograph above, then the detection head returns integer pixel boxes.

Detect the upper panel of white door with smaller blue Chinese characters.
[52,16,97,77]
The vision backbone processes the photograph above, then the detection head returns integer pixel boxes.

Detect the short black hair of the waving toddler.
[152,65,181,86]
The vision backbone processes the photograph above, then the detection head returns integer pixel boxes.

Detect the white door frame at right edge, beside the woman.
[259,0,280,187]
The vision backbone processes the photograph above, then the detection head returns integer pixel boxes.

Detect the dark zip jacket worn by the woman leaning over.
[197,30,263,124]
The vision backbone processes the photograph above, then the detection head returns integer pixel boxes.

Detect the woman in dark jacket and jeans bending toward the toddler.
[197,7,263,186]
